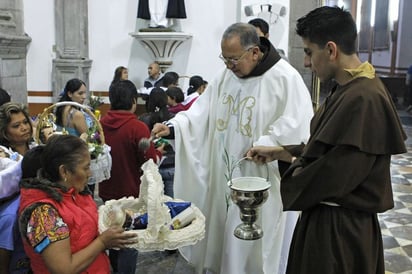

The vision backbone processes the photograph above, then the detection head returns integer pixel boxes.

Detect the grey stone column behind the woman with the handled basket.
[52,0,92,100]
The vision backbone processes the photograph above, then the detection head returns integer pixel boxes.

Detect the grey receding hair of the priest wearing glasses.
[222,23,260,49]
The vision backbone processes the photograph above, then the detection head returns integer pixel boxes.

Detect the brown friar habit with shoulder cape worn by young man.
[281,71,406,274]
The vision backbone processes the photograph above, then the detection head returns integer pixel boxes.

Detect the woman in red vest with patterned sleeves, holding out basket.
[19,135,135,273]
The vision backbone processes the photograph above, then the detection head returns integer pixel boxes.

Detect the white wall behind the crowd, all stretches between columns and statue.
[23,0,289,91]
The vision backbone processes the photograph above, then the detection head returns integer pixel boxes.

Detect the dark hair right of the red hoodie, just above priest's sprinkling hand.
[139,88,174,130]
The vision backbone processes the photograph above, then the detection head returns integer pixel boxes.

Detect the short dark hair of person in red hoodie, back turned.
[109,80,138,110]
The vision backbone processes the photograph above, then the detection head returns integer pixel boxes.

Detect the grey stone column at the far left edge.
[0,0,31,104]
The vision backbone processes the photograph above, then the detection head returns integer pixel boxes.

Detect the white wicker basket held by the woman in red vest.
[99,159,205,251]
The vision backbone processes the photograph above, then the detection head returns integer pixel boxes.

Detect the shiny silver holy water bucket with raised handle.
[228,158,271,240]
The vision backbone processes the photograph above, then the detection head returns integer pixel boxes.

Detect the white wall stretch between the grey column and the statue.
[89,0,137,91]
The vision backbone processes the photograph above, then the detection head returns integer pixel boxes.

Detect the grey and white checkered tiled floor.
[100,108,412,274]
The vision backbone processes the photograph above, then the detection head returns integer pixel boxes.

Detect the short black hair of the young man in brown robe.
[296,6,357,54]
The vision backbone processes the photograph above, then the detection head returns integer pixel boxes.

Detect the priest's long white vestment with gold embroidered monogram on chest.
[170,59,313,274]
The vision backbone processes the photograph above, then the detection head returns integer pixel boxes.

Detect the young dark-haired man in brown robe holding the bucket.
[247,7,406,274]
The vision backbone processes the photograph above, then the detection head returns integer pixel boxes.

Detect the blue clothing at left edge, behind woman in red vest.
[0,195,30,274]
